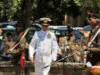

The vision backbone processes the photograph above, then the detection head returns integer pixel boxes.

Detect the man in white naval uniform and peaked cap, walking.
[29,18,59,75]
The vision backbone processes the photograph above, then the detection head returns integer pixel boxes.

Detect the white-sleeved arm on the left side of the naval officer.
[29,32,37,61]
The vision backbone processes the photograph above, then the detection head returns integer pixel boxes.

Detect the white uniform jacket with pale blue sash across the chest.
[29,30,59,65]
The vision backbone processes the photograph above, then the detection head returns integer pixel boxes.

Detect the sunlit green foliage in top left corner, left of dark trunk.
[0,0,20,21]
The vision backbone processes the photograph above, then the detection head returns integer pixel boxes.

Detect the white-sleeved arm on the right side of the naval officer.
[52,35,60,61]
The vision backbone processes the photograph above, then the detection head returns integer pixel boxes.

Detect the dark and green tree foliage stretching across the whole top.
[0,0,100,24]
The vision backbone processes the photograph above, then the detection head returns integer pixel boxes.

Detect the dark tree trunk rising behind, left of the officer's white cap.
[19,0,34,29]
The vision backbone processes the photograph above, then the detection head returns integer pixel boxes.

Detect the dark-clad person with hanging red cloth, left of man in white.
[15,21,29,75]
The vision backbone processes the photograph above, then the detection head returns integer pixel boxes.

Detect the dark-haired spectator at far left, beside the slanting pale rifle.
[2,32,16,61]
